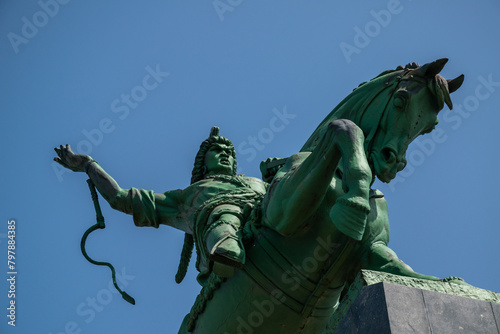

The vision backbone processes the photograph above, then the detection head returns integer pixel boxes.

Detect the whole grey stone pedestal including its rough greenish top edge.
[323,271,500,334]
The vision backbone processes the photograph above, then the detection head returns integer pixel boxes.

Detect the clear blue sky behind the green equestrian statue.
[0,0,500,334]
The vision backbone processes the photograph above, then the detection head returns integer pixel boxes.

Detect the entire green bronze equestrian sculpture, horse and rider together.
[55,59,466,334]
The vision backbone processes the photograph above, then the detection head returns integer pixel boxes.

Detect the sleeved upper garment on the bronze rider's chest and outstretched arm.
[113,175,267,272]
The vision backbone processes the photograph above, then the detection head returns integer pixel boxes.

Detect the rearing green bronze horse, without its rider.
[179,59,464,334]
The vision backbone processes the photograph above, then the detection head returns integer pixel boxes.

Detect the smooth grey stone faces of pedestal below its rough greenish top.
[333,282,500,334]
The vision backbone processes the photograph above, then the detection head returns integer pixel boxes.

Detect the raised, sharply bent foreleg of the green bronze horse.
[264,120,372,240]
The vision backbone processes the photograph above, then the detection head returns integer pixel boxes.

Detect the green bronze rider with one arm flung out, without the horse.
[54,127,267,285]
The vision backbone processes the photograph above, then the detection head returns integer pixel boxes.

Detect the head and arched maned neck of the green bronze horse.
[302,58,464,182]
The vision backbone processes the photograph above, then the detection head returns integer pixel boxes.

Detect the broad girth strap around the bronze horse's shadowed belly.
[244,233,343,317]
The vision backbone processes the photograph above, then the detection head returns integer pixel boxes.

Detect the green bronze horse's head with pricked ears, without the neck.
[359,58,464,182]
